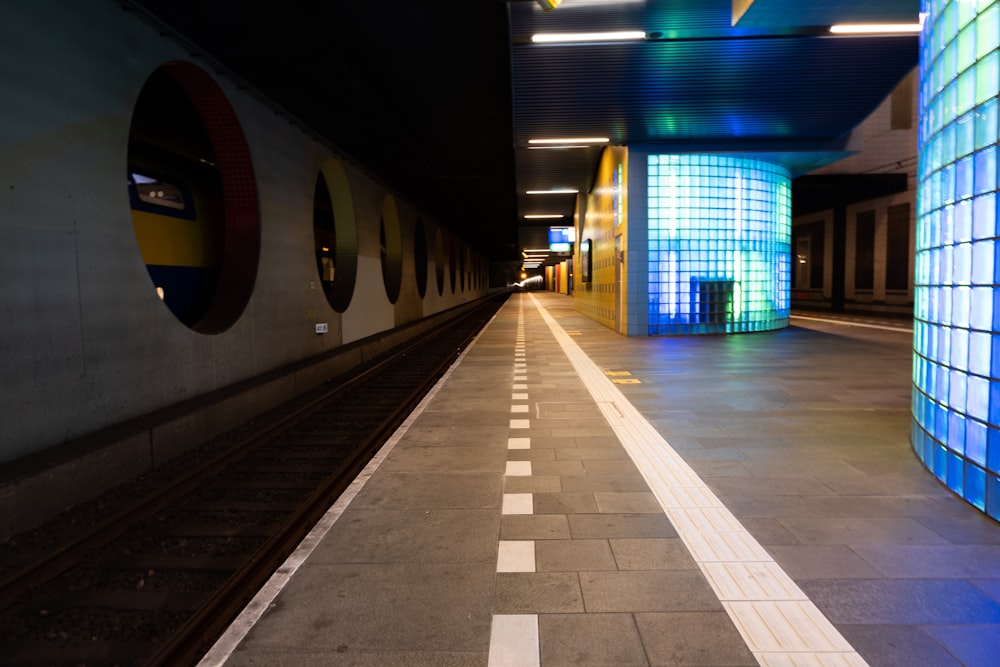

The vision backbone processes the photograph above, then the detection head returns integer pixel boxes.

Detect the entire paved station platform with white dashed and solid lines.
[202,292,1000,667]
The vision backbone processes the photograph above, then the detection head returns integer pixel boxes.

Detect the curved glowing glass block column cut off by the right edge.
[911,0,1000,518]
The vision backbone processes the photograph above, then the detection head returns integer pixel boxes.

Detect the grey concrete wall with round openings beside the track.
[0,0,487,532]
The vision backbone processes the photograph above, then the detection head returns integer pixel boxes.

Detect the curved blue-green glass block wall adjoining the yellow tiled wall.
[647,155,792,336]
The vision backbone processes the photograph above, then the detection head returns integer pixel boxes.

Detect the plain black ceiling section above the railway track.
[129,0,517,259]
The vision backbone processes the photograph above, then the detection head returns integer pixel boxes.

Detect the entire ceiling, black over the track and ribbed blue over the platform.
[121,0,919,268]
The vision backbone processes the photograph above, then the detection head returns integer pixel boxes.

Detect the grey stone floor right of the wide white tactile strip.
[545,296,1000,667]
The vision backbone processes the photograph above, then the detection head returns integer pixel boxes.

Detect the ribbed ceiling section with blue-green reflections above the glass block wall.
[513,37,918,146]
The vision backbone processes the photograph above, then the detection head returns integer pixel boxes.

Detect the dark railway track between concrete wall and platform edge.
[0,299,502,667]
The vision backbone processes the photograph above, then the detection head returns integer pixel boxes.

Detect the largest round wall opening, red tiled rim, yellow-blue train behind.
[127,62,260,334]
